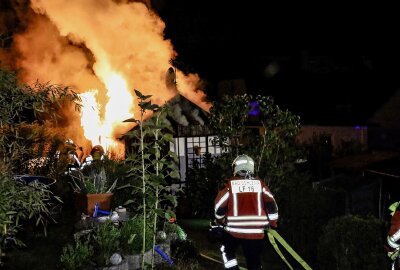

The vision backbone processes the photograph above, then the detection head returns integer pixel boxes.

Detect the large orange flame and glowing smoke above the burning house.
[0,0,210,158]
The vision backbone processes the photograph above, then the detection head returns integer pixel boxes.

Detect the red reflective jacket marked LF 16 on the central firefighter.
[214,177,278,239]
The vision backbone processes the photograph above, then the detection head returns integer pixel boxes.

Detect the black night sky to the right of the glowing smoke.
[155,1,400,124]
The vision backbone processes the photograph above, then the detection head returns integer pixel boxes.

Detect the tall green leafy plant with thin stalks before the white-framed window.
[125,90,179,268]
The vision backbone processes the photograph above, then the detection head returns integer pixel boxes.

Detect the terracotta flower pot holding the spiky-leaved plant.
[75,193,114,216]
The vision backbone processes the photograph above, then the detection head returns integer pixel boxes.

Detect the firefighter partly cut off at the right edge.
[387,202,400,270]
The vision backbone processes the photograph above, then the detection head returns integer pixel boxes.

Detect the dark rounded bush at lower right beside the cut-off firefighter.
[318,215,390,270]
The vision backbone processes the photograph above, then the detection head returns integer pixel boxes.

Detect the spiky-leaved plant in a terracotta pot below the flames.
[70,161,117,215]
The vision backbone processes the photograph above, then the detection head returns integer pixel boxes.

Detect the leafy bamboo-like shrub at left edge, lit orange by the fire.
[0,69,79,263]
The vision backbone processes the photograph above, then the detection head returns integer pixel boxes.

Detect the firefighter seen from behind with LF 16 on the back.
[215,155,278,270]
